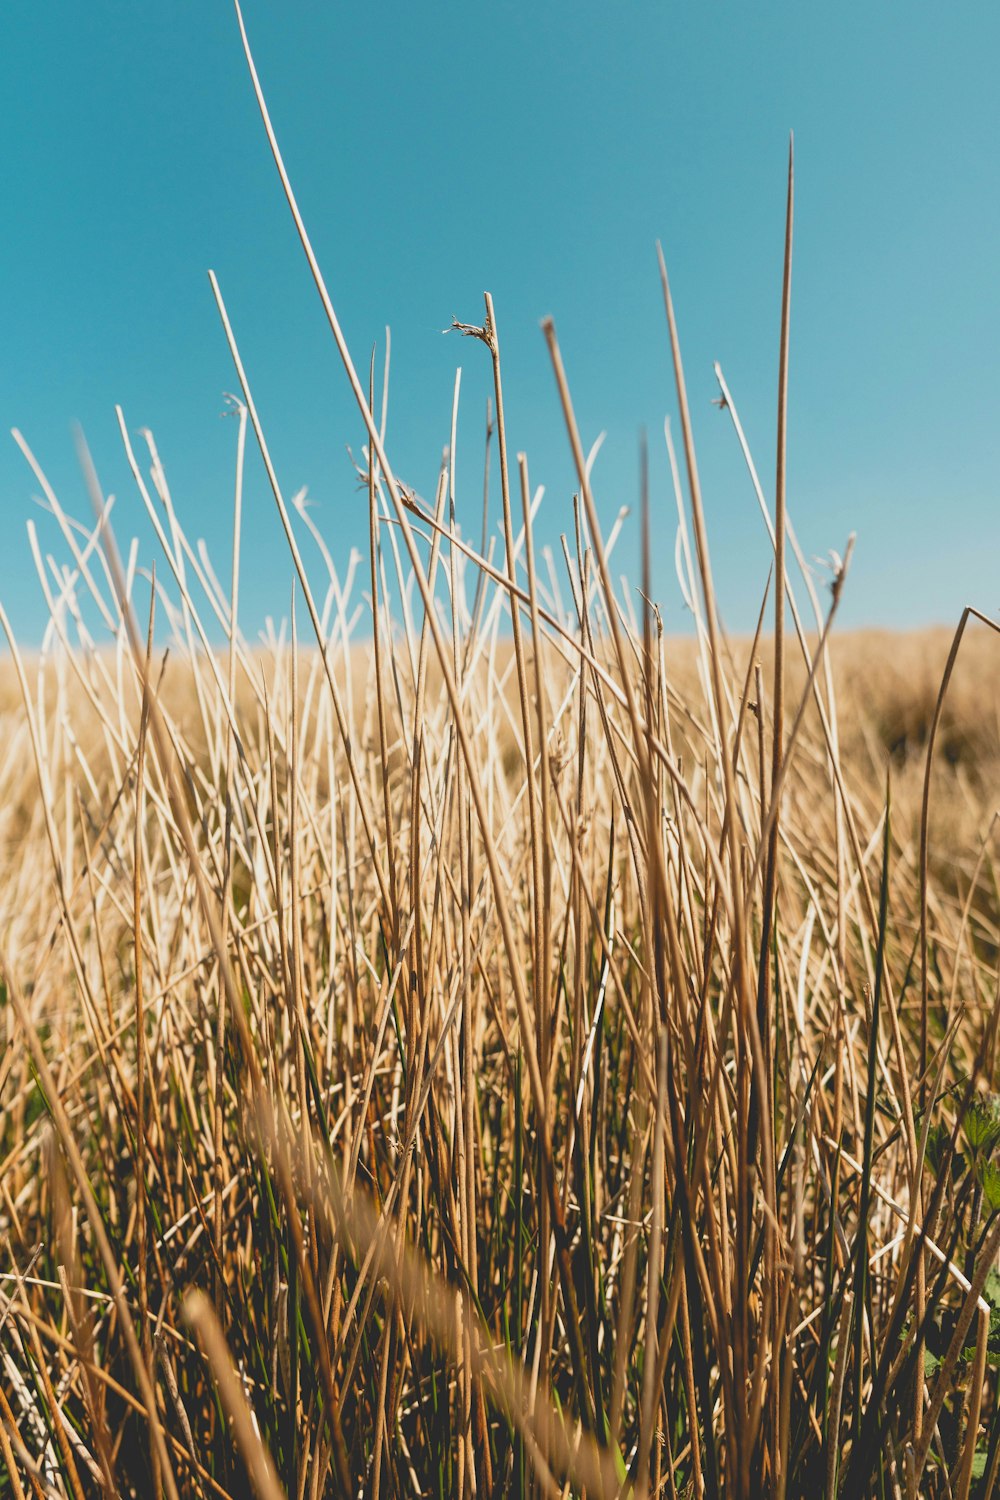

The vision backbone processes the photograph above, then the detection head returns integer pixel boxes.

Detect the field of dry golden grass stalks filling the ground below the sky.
[0,5,1000,1500]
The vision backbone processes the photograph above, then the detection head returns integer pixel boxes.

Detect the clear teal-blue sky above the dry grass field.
[0,0,1000,641]
